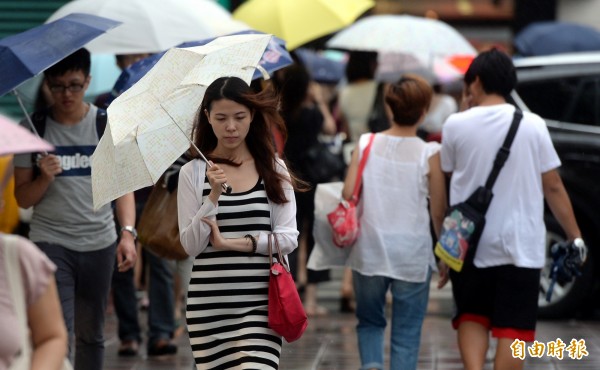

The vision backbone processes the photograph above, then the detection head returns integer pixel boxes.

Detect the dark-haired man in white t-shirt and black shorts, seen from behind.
[441,49,581,370]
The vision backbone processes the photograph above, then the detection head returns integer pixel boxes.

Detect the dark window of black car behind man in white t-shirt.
[516,76,600,126]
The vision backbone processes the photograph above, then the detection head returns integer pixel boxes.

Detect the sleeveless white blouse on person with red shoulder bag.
[347,133,440,282]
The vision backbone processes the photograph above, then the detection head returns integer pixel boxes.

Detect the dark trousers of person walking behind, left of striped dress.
[113,252,175,346]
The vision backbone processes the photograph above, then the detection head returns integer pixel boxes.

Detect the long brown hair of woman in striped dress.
[192,77,297,204]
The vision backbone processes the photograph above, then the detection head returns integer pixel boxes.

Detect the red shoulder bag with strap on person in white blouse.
[327,134,375,248]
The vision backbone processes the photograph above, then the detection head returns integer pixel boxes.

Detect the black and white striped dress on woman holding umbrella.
[186,178,281,370]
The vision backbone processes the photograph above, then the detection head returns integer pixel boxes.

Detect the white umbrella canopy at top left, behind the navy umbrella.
[48,0,249,54]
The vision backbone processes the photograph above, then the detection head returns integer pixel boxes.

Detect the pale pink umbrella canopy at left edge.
[0,115,54,156]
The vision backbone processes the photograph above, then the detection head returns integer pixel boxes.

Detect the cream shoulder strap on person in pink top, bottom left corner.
[0,234,31,357]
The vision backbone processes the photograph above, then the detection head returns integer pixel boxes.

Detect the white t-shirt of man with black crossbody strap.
[441,104,560,268]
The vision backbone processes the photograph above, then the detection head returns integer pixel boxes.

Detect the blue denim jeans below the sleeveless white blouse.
[352,270,431,370]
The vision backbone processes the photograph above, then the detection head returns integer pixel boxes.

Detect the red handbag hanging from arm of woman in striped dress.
[268,233,308,343]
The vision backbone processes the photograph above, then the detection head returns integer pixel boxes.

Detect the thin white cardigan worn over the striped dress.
[177,159,298,257]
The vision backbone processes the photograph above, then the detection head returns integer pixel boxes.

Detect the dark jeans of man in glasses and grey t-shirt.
[36,242,116,370]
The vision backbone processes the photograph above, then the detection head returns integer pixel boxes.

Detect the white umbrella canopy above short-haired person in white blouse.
[326,15,477,67]
